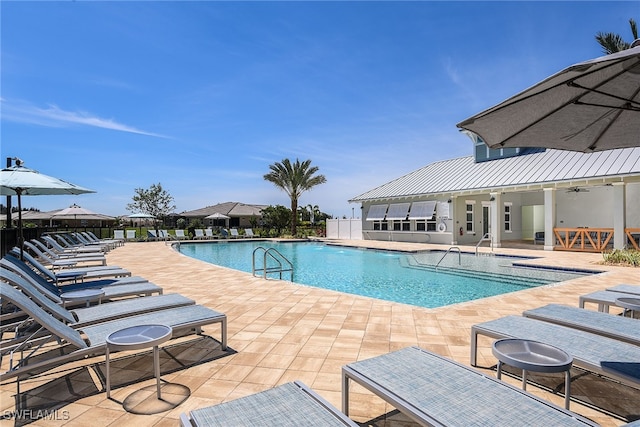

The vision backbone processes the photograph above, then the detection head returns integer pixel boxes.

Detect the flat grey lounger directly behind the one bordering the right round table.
[522,304,640,345]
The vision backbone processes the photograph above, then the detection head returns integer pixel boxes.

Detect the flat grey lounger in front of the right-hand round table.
[342,347,597,427]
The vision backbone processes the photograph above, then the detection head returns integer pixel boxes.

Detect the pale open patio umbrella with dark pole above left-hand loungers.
[0,159,95,258]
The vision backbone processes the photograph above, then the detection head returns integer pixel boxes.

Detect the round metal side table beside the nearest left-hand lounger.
[106,325,172,399]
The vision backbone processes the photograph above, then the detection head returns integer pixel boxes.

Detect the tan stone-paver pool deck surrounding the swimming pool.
[0,241,640,427]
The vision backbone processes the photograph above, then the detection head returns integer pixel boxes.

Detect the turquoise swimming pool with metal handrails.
[180,241,594,308]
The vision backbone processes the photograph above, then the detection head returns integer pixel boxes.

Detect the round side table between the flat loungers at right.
[492,339,573,409]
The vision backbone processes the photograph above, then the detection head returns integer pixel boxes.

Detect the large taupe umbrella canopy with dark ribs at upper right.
[457,39,640,153]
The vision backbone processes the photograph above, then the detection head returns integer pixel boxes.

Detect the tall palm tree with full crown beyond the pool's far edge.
[264,159,327,236]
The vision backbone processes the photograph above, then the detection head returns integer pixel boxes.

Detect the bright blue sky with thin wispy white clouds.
[0,1,639,217]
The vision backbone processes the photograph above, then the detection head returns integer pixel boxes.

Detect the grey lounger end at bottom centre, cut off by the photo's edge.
[180,381,357,427]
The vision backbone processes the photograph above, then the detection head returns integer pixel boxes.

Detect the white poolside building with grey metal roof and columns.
[349,139,640,250]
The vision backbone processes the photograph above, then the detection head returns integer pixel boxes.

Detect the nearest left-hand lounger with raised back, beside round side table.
[0,289,227,384]
